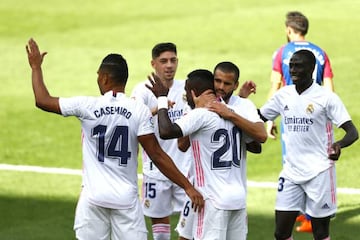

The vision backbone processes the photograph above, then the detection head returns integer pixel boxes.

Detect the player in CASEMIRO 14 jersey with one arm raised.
[26,39,204,240]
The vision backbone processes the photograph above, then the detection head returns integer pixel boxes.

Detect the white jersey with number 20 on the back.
[175,108,246,210]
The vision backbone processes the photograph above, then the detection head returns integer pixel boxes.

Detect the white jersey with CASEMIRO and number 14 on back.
[59,91,154,209]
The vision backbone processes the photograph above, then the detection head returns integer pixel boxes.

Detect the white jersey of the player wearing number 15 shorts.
[131,80,191,180]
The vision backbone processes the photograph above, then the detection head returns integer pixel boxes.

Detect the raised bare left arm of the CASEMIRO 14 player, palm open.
[26,38,61,114]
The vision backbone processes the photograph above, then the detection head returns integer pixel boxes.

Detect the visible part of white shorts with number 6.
[175,197,195,239]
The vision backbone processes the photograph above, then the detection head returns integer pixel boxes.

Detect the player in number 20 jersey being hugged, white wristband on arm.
[149,70,266,239]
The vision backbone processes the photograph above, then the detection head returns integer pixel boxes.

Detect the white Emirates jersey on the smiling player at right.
[260,83,351,183]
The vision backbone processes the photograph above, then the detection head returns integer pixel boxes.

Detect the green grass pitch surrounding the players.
[0,0,360,239]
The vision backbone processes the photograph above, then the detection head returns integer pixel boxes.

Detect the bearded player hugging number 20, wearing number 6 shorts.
[176,62,267,240]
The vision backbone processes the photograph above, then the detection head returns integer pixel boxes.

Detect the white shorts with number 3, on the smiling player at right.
[275,167,337,218]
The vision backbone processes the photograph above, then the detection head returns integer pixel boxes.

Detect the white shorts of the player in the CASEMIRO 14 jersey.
[74,193,147,240]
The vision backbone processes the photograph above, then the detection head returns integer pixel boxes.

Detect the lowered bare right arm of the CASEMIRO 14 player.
[138,133,204,211]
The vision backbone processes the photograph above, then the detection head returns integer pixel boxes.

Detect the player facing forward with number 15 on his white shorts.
[131,42,191,240]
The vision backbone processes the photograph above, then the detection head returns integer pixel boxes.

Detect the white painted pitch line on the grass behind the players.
[0,164,360,195]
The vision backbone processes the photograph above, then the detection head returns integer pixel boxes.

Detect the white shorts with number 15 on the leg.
[142,175,186,218]
